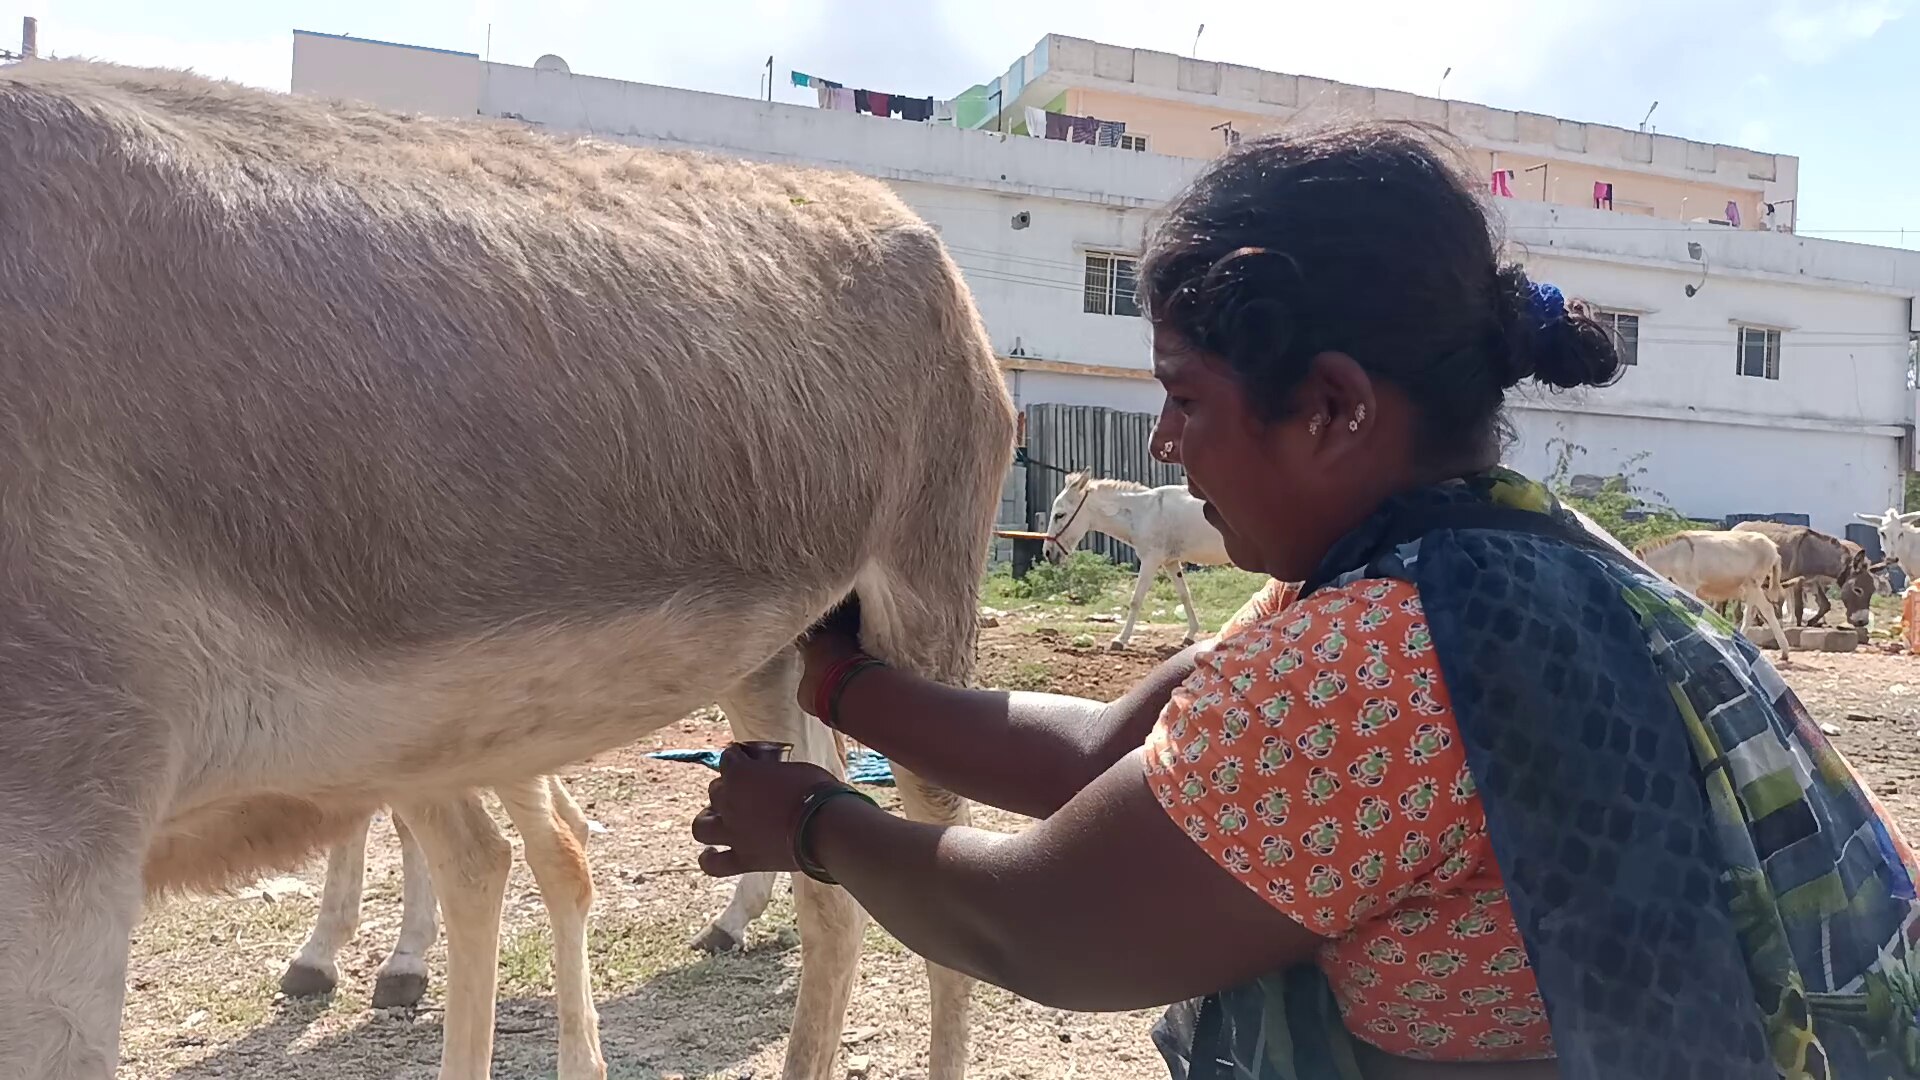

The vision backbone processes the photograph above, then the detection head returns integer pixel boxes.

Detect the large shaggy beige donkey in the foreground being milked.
[0,61,1014,1080]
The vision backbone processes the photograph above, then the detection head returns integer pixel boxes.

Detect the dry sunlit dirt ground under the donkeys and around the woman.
[119,621,1920,1080]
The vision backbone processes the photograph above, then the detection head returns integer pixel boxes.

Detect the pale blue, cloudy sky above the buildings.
[0,0,1920,248]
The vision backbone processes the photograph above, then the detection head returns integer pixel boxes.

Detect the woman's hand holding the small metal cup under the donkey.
[693,748,841,878]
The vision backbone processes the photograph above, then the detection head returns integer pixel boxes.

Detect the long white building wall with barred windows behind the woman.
[292,31,1920,532]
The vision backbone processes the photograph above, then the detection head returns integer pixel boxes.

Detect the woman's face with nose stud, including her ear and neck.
[1152,331,1405,580]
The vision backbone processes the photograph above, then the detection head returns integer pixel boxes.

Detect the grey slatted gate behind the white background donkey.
[1027,405,1187,567]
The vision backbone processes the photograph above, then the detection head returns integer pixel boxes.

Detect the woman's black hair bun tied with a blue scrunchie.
[1490,263,1624,390]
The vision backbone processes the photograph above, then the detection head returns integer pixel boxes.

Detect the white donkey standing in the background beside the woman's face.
[1046,473,1229,650]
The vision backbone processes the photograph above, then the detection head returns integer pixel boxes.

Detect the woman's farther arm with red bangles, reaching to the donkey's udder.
[801,626,1200,817]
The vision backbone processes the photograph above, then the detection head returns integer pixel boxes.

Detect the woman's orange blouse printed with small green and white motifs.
[1146,578,1551,1061]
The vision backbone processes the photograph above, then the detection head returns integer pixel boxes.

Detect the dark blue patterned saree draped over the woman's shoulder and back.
[1154,469,1920,1080]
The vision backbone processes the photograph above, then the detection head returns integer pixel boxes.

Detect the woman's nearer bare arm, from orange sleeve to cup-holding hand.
[703,749,1323,1011]
